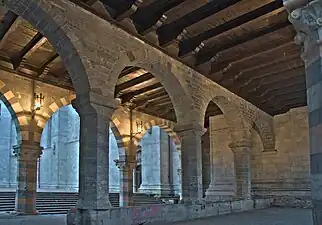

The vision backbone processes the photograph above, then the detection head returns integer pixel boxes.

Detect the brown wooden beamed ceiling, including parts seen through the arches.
[0,0,306,125]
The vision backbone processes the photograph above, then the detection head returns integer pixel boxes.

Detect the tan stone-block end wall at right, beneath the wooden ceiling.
[252,107,310,207]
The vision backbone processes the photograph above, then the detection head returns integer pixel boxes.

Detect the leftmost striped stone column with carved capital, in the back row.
[14,141,42,214]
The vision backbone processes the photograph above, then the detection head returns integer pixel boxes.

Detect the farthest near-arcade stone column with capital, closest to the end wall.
[229,141,251,199]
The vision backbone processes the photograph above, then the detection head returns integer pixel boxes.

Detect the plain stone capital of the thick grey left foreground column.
[72,92,118,118]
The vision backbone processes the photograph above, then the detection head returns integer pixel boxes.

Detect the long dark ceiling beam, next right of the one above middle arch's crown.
[157,0,241,46]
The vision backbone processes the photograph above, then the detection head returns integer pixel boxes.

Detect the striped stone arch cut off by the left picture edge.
[0,80,25,143]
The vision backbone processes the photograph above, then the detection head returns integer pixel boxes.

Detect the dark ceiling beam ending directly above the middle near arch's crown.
[131,0,186,35]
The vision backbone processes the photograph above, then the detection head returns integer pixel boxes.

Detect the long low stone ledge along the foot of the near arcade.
[67,199,272,225]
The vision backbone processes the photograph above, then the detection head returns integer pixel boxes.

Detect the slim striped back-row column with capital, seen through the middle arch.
[115,156,135,207]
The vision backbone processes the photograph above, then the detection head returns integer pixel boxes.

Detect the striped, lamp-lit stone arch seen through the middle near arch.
[131,118,181,151]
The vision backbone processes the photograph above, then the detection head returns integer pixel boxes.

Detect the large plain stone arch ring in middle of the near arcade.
[110,48,193,123]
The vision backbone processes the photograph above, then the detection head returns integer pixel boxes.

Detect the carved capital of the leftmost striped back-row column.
[13,143,42,160]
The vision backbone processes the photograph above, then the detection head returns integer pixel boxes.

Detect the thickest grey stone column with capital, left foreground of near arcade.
[72,93,115,214]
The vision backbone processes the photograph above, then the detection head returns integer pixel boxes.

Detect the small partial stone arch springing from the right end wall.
[253,117,276,152]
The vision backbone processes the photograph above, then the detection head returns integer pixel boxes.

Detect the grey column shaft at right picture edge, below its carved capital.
[306,58,322,224]
